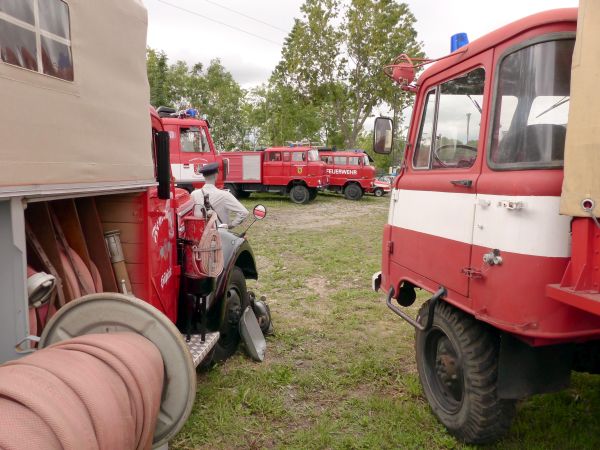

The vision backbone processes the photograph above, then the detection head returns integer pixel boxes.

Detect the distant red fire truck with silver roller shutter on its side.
[221,146,327,203]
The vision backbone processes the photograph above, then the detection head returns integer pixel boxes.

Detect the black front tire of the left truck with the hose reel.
[213,266,250,362]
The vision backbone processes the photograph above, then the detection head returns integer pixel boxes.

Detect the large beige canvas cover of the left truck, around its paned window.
[0,0,154,194]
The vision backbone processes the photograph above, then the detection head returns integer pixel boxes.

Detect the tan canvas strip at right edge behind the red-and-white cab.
[560,0,600,217]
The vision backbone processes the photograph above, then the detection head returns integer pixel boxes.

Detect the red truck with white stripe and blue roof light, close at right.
[373,1,600,443]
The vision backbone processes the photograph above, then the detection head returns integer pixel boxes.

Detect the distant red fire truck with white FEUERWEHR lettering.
[319,150,376,200]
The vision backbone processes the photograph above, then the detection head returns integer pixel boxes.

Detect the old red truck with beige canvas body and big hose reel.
[0,0,268,449]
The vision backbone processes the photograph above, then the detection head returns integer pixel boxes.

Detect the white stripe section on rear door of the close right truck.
[473,195,571,257]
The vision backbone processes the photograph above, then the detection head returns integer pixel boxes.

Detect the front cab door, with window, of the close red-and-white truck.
[389,54,492,296]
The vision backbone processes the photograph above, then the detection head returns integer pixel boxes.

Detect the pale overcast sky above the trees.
[143,0,578,88]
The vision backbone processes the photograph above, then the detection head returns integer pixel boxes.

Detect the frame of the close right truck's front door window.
[410,67,488,171]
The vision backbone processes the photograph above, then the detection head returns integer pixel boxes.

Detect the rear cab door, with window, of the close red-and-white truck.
[471,37,576,320]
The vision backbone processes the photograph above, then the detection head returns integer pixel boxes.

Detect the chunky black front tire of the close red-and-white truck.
[415,302,515,444]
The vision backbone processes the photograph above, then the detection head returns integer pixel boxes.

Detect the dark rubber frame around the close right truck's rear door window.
[485,31,576,172]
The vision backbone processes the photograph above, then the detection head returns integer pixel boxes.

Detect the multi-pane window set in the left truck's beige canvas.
[0,0,74,81]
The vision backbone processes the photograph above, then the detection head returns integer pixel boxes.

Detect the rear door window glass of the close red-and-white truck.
[489,39,575,169]
